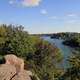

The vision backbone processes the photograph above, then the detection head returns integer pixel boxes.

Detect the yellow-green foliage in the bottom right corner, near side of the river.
[59,52,80,80]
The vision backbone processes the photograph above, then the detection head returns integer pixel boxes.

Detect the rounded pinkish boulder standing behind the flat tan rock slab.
[4,54,24,72]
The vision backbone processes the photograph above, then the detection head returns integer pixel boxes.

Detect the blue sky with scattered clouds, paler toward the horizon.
[0,0,80,34]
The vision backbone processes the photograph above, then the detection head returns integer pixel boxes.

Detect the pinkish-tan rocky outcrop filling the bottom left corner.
[0,55,32,80]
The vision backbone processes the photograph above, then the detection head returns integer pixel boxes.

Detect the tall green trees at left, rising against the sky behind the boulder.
[0,25,29,57]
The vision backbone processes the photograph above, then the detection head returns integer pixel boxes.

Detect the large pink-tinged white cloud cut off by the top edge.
[22,0,41,7]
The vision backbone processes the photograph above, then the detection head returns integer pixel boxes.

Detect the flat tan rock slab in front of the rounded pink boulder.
[0,64,16,80]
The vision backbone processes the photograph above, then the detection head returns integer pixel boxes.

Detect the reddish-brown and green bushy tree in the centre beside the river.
[27,39,61,80]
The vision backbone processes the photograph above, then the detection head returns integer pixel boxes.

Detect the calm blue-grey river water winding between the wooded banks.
[42,37,72,68]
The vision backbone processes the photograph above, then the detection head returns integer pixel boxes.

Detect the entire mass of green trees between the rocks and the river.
[0,25,61,80]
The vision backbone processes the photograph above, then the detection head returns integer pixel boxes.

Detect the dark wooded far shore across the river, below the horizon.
[51,32,80,48]
